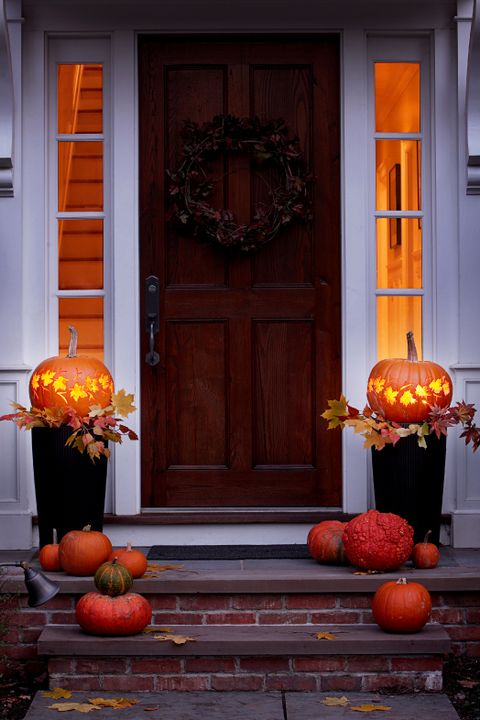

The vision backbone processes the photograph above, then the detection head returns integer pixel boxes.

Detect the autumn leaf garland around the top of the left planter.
[0,389,138,461]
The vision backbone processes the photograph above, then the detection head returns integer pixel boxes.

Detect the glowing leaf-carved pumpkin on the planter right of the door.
[367,332,452,423]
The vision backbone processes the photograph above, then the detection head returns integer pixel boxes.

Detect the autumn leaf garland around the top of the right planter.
[322,394,480,452]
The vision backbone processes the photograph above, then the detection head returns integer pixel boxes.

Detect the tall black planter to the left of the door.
[32,425,107,547]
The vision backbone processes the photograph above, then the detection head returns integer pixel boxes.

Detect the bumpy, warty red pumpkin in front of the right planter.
[343,510,413,570]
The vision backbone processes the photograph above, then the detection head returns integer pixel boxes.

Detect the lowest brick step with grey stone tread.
[38,623,450,693]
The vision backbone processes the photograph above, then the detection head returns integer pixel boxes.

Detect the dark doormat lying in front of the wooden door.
[147,545,310,560]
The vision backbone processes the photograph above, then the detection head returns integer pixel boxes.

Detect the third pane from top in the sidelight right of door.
[377,218,422,288]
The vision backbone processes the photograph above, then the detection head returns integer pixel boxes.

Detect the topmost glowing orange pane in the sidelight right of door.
[375,63,420,132]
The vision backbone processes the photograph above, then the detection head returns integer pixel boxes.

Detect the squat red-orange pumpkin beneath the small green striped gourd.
[75,592,152,635]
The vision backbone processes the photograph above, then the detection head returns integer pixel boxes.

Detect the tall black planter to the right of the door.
[372,434,447,545]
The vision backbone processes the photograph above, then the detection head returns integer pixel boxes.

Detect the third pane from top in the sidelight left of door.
[58,220,103,290]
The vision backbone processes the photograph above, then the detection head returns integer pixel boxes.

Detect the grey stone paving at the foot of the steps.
[25,692,459,720]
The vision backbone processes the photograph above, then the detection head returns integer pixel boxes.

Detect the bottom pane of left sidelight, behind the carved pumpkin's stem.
[58,298,103,360]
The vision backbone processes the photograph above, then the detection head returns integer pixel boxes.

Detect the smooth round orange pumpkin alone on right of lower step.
[372,578,432,633]
